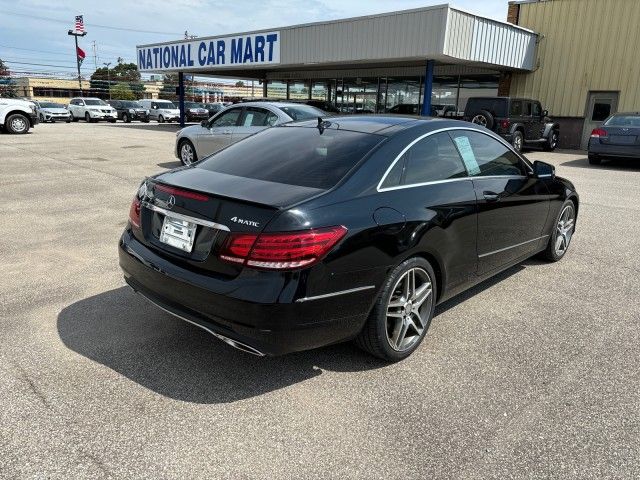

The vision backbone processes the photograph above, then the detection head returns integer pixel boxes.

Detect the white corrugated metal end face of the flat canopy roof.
[444,8,537,70]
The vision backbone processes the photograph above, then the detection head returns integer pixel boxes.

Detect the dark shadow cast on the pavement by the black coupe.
[57,260,541,404]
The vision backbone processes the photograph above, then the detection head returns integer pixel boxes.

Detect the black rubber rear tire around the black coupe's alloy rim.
[355,257,437,362]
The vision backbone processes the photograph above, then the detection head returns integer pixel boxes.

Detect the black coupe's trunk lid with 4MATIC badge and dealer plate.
[136,167,322,276]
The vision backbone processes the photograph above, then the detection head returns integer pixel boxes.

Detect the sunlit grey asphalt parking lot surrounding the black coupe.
[0,123,640,479]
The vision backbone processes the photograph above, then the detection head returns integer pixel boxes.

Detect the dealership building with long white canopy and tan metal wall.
[136,0,640,148]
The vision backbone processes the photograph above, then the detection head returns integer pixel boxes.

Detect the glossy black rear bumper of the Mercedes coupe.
[119,231,375,355]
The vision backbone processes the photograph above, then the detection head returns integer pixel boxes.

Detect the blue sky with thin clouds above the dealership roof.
[0,0,507,80]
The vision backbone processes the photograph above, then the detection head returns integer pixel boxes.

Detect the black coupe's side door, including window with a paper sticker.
[451,129,550,275]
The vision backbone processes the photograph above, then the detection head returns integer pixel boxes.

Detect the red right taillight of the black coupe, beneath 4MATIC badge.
[220,226,347,270]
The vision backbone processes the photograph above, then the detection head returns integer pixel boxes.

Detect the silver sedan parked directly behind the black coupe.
[175,102,328,165]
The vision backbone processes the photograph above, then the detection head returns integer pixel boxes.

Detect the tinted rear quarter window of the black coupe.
[399,132,467,185]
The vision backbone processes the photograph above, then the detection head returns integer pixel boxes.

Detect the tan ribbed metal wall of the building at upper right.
[511,0,640,117]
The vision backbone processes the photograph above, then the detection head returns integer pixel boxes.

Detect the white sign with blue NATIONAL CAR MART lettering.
[137,32,280,71]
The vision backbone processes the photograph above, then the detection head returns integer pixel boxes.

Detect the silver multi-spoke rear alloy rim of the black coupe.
[386,267,433,352]
